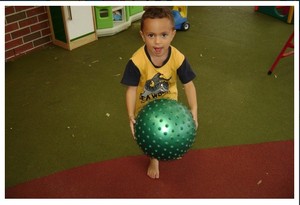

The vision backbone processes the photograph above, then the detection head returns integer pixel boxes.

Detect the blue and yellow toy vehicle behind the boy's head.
[172,6,190,31]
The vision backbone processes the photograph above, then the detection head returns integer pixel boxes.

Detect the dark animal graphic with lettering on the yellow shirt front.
[140,73,172,102]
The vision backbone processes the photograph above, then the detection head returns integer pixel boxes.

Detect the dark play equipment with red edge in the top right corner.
[254,6,294,23]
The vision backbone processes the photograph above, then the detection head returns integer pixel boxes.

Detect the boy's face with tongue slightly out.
[140,18,176,57]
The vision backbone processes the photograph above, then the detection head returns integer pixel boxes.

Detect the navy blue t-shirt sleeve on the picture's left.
[121,60,141,86]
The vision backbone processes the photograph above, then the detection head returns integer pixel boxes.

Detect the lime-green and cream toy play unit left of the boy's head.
[94,6,144,37]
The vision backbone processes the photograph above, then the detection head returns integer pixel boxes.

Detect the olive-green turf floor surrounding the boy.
[5,7,294,187]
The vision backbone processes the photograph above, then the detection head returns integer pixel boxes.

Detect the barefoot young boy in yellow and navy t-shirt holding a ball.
[121,7,198,179]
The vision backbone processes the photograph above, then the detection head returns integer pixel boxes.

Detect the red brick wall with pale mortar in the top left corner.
[5,6,52,61]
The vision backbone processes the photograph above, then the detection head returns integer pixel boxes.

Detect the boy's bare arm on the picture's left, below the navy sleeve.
[126,86,137,139]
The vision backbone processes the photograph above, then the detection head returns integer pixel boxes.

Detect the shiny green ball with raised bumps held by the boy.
[134,99,196,160]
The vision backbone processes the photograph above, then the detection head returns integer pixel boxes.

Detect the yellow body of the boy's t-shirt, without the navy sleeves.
[131,46,185,115]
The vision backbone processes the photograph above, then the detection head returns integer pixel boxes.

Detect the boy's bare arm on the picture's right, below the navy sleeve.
[184,81,198,129]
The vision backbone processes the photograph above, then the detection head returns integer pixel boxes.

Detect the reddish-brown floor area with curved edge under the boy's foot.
[5,141,294,198]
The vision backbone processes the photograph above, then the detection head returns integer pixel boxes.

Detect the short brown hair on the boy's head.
[141,7,175,31]
